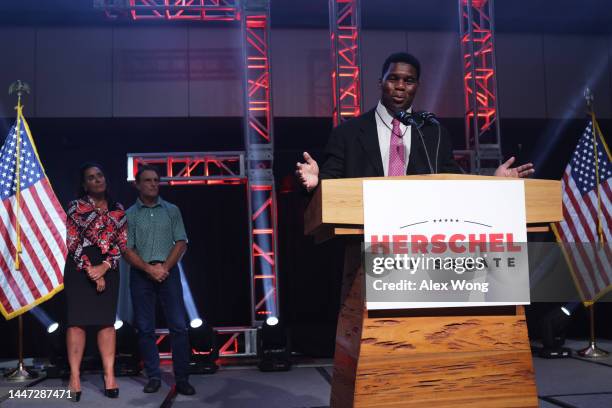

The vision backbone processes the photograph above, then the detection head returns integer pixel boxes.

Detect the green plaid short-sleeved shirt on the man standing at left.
[126,197,187,262]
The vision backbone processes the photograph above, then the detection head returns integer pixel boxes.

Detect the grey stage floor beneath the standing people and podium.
[0,340,612,408]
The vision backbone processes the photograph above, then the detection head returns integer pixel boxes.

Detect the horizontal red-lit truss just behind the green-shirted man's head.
[127,151,247,186]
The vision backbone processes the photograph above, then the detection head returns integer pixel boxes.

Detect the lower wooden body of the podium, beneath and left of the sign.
[331,240,538,408]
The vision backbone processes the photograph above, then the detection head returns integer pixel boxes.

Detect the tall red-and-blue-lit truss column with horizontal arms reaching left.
[117,0,279,356]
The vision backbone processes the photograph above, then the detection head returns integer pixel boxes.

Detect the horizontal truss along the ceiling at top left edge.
[94,0,240,21]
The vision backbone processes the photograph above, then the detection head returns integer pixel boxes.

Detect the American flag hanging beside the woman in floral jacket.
[0,109,67,319]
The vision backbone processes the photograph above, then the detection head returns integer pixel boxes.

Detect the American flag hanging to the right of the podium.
[553,117,612,301]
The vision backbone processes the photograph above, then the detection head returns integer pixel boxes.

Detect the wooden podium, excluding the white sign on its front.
[305,174,563,408]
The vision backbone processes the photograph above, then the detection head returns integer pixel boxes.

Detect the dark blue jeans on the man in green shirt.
[130,266,191,382]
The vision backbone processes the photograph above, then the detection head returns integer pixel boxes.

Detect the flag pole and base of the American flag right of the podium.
[578,88,609,358]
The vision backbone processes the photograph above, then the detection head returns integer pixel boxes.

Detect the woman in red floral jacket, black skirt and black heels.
[64,163,127,401]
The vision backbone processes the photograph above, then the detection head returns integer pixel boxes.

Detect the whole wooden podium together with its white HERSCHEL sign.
[305,174,563,408]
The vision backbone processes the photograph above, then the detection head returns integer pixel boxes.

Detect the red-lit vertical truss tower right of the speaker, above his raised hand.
[459,0,502,174]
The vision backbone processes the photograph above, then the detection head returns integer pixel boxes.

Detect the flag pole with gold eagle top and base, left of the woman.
[4,80,38,381]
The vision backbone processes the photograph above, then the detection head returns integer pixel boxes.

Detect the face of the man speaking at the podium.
[380,62,419,112]
